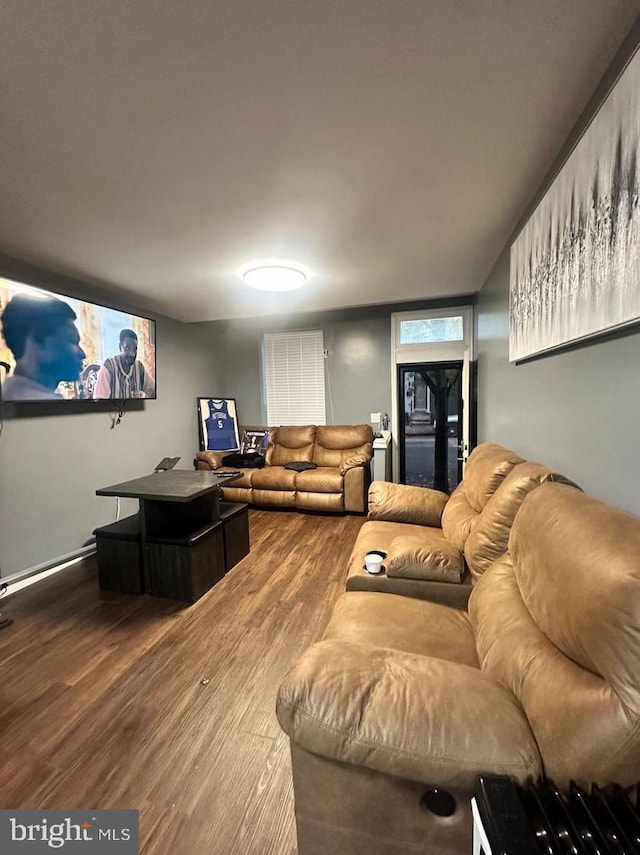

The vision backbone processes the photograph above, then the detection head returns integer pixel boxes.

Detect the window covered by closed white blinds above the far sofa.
[262,330,326,427]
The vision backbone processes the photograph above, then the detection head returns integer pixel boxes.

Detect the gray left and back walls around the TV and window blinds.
[0,268,468,577]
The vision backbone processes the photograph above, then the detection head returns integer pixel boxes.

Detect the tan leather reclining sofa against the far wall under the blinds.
[195,425,373,513]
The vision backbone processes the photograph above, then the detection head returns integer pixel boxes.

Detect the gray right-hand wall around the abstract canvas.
[477,19,640,513]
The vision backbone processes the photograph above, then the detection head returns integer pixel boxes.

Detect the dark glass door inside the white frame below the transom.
[398,361,462,493]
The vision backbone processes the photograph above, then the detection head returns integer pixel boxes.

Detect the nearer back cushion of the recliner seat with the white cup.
[464,462,579,579]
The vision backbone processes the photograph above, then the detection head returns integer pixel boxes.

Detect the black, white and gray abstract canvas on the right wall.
[509,47,640,362]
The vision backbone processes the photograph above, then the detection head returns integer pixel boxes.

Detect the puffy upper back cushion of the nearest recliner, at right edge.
[509,484,640,716]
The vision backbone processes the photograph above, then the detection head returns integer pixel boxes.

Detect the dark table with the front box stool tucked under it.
[96,469,240,602]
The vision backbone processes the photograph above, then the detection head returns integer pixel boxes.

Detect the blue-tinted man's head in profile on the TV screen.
[2,294,85,401]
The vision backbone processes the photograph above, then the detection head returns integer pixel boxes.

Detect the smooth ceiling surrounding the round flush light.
[0,0,640,321]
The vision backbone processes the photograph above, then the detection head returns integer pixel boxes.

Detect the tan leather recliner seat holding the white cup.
[347,442,575,608]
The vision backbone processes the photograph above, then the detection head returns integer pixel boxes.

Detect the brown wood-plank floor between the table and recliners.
[0,511,364,855]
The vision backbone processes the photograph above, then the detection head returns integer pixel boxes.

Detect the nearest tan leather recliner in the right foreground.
[277,444,640,855]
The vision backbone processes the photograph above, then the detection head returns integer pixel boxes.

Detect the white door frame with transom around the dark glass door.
[391,304,475,482]
